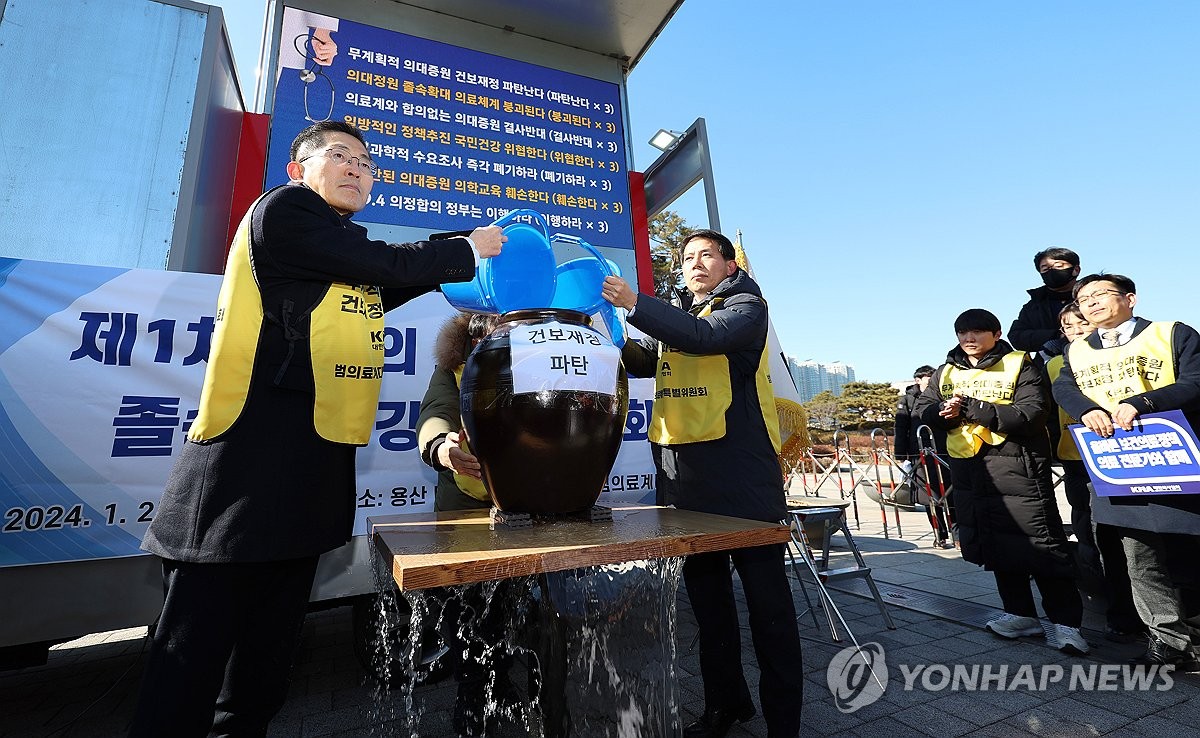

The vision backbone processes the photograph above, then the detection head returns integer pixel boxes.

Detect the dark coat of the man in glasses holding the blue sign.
[1054,318,1200,535]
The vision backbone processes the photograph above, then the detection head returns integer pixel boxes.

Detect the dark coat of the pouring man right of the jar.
[622,269,787,522]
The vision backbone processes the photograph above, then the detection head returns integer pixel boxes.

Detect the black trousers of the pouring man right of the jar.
[683,544,804,738]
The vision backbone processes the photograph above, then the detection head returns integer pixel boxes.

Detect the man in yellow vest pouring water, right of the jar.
[602,229,804,738]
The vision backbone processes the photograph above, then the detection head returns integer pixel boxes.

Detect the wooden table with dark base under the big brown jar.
[370,506,790,738]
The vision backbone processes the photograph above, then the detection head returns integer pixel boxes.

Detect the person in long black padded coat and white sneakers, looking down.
[918,308,1088,654]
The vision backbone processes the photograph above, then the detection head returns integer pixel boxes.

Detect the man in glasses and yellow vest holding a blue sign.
[1054,275,1200,671]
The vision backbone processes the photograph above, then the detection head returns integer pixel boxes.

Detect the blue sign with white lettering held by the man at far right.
[1070,410,1200,497]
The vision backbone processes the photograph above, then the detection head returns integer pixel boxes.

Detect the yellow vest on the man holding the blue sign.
[1067,322,1175,413]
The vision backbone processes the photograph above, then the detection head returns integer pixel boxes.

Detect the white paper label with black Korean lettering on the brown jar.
[509,322,620,395]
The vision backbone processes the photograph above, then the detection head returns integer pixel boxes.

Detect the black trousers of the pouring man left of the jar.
[130,557,318,738]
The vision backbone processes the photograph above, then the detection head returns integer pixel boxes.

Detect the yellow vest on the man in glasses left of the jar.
[187,193,384,445]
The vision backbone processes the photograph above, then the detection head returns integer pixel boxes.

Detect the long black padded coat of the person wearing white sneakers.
[918,341,1074,576]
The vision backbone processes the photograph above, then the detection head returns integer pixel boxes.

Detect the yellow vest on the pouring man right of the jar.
[648,298,780,454]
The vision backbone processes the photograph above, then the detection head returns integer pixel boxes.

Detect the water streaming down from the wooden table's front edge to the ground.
[360,544,683,738]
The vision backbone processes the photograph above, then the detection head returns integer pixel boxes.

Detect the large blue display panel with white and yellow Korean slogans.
[266,7,634,248]
